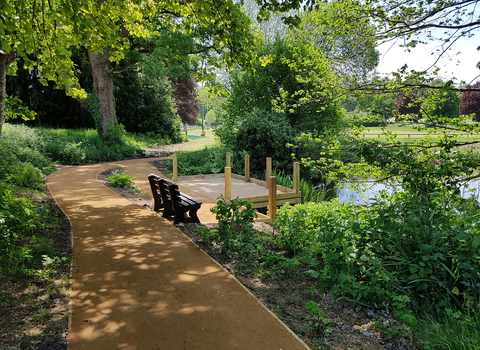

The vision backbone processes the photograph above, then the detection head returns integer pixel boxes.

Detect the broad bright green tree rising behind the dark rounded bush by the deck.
[221,39,341,145]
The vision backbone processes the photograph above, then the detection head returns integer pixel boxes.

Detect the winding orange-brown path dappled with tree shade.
[48,159,308,350]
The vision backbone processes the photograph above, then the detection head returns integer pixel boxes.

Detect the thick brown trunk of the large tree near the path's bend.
[88,51,117,138]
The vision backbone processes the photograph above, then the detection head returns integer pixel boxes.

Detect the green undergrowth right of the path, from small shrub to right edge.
[196,192,480,349]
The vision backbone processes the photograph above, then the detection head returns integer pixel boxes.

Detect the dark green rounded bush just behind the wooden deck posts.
[233,111,295,178]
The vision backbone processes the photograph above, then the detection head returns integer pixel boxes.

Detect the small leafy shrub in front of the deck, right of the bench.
[210,195,256,251]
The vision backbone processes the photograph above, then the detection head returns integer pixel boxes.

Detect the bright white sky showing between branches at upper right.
[377,36,480,84]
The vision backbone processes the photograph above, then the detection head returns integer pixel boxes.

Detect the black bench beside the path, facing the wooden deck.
[148,174,202,224]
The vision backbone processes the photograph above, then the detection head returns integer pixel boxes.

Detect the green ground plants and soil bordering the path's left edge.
[0,127,71,349]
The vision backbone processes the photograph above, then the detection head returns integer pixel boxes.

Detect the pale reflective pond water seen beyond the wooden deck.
[336,181,480,204]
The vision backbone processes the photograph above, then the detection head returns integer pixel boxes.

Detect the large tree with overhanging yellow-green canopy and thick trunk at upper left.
[0,0,306,136]
